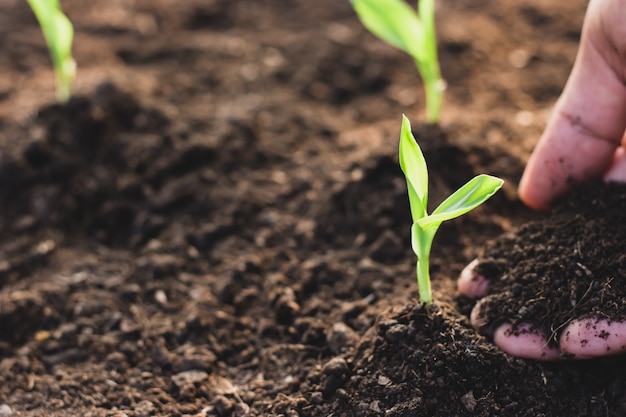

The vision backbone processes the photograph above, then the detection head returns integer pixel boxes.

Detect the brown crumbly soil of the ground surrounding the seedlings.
[0,0,626,417]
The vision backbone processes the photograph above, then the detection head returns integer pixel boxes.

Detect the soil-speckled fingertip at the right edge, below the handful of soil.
[560,319,626,359]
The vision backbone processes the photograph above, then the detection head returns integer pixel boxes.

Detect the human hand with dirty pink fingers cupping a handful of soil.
[458,0,626,360]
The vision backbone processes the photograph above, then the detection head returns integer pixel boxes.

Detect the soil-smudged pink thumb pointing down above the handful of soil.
[519,1,626,209]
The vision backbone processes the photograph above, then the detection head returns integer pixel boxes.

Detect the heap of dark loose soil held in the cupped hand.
[477,183,626,344]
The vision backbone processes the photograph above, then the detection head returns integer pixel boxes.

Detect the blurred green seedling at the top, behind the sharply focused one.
[350,0,445,124]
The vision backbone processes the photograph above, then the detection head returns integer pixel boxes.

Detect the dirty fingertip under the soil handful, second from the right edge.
[493,323,561,361]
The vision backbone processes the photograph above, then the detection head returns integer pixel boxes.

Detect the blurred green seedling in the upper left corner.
[28,0,76,103]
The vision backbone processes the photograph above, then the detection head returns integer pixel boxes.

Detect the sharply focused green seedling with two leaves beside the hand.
[400,116,504,305]
